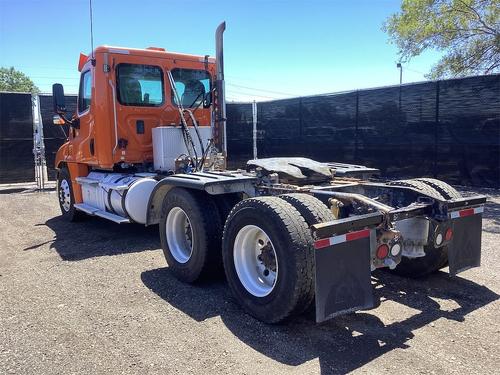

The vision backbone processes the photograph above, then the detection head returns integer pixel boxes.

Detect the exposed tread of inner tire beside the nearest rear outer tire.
[279,193,335,226]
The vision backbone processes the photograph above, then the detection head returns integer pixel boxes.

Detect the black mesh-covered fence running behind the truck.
[0,75,500,188]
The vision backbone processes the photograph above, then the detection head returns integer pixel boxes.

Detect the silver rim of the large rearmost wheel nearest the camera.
[233,225,278,297]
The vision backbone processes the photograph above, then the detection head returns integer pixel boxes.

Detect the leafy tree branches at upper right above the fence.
[383,0,500,78]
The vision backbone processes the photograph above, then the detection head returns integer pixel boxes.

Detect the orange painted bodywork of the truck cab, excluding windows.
[56,46,215,172]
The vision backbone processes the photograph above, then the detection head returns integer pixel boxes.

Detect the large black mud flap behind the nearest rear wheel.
[314,229,376,323]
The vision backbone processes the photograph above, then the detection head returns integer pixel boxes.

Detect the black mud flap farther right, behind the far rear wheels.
[448,206,483,275]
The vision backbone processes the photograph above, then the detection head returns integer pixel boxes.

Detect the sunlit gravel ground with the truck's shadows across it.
[0,190,500,374]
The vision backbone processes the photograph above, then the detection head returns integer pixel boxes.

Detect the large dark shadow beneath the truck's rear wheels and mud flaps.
[141,268,499,374]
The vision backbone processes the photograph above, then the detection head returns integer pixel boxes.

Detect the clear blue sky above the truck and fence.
[0,0,439,101]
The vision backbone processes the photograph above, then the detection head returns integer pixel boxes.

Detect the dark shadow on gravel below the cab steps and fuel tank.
[34,216,160,261]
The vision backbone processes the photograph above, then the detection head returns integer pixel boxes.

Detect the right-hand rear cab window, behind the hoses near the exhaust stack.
[172,68,210,108]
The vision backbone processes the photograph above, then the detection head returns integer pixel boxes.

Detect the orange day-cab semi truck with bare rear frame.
[53,23,486,323]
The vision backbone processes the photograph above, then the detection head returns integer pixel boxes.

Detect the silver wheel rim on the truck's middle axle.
[165,207,194,263]
